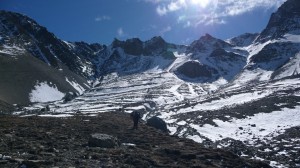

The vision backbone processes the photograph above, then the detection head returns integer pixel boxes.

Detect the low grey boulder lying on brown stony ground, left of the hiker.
[89,133,119,148]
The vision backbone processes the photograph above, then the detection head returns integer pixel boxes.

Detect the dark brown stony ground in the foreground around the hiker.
[0,113,269,168]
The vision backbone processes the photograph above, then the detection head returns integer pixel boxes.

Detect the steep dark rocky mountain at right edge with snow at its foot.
[236,0,300,83]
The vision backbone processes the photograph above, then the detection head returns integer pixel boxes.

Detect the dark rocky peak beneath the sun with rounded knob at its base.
[172,34,246,82]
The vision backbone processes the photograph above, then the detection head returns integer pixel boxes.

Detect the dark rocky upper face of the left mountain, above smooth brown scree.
[0,11,87,75]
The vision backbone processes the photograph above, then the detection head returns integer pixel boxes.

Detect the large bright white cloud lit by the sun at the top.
[144,0,286,27]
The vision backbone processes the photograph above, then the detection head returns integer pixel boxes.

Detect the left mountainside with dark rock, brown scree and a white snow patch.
[0,11,89,104]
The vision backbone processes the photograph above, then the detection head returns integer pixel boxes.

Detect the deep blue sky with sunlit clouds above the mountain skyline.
[0,0,286,44]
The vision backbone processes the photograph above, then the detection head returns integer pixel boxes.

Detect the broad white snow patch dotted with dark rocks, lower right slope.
[190,106,300,144]
